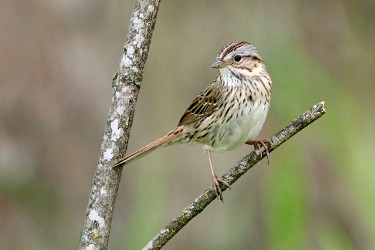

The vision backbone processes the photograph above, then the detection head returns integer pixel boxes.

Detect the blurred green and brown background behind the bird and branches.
[0,0,375,249]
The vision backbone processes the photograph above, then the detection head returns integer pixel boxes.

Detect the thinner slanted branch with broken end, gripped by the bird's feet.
[144,102,326,249]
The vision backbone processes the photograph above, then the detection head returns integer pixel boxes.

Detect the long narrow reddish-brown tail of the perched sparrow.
[112,126,182,168]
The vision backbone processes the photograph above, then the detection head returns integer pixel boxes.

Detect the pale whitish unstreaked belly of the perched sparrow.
[204,101,269,152]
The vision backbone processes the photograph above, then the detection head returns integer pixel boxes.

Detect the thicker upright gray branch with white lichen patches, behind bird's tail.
[80,0,160,249]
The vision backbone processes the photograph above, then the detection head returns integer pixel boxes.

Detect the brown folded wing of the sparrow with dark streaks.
[178,81,221,126]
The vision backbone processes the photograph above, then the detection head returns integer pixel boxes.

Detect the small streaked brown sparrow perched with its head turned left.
[112,42,272,201]
